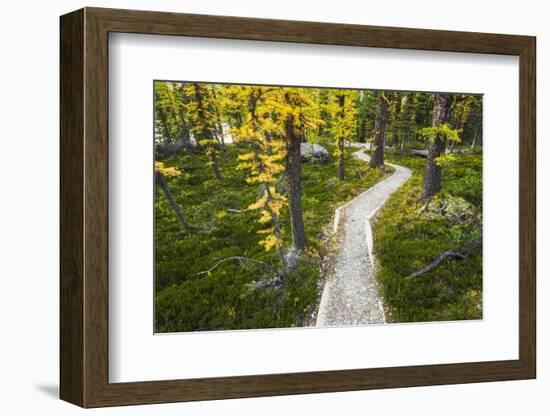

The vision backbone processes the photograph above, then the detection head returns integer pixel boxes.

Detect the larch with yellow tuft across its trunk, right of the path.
[420,93,460,200]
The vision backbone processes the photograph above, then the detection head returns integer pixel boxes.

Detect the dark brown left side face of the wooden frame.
[59,10,85,406]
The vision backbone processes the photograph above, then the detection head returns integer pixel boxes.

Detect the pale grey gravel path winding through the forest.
[316,146,411,326]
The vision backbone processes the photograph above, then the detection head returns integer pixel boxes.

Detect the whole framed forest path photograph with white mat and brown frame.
[60,8,536,407]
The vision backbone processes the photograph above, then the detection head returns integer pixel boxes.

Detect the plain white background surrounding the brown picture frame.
[0,0,550,416]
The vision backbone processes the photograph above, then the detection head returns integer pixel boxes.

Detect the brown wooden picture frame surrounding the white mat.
[60,8,536,407]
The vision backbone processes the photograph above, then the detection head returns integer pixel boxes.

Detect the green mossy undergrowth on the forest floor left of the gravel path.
[155,143,390,332]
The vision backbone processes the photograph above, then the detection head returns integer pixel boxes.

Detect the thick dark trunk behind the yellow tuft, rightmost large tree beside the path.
[421,94,449,200]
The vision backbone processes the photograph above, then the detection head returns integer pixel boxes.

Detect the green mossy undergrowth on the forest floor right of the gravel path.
[374,154,482,322]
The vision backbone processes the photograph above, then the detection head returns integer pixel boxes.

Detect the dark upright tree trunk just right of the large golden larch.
[285,115,306,251]
